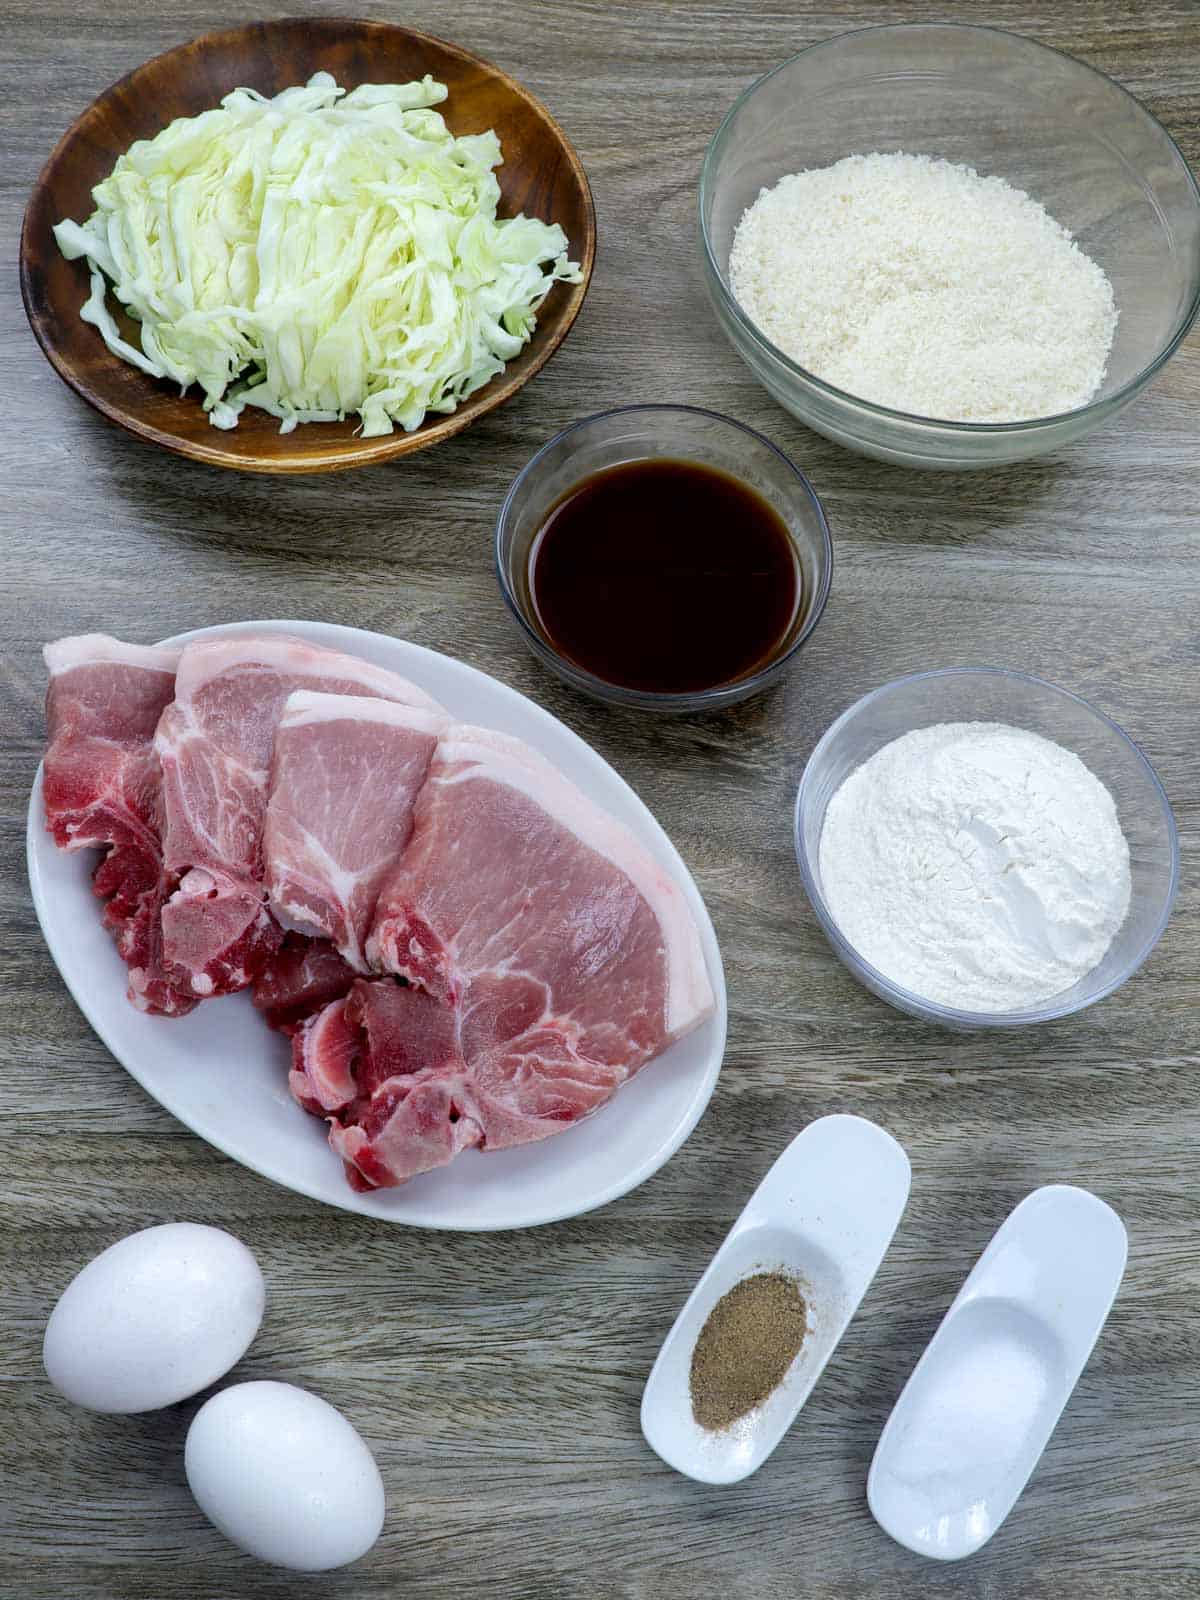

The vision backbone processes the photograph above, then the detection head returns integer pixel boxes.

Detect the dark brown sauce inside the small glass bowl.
[530,461,802,694]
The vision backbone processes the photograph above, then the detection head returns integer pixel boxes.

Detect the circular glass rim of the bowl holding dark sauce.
[493,400,834,709]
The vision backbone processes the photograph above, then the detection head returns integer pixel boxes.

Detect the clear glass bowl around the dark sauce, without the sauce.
[496,405,834,712]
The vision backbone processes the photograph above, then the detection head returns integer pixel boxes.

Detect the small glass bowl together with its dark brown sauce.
[496,403,834,715]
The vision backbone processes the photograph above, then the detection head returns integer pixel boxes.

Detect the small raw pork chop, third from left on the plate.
[262,691,446,973]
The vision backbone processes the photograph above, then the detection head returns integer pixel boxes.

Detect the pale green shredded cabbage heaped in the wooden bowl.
[54,72,581,435]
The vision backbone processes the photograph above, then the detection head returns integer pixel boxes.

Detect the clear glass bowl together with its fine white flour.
[795,667,1179,1029]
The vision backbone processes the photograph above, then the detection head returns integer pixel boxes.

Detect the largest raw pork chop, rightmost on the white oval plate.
[291,726,714,1186]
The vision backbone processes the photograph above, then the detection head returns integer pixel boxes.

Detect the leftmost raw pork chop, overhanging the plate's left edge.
[43,634,195,1016]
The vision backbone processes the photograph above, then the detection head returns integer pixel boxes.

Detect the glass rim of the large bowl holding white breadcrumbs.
[699,22,1200,437]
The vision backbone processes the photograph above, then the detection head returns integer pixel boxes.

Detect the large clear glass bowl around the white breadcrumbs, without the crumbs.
[699,22,1200,470]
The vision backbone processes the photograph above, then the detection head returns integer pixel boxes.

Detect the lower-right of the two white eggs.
[184,1382,384,1573]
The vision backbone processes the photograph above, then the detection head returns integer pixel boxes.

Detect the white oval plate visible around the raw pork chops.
[27,622,726,1230]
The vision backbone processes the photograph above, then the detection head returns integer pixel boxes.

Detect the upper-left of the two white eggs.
[42,1222,266,1411]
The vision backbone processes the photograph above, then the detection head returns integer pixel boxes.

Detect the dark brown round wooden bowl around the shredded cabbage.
[21,18,595,472]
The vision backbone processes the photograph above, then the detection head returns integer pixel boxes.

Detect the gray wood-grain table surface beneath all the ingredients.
[0,0,1200,1600]
